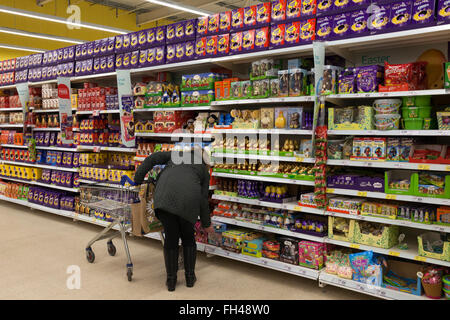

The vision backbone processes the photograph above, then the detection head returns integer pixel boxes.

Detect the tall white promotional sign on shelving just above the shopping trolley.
[117,70,135,148]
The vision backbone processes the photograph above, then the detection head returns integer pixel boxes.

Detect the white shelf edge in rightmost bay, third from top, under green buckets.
[328,130,450,137]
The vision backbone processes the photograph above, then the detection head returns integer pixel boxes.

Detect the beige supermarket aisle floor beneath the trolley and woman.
[0,202,370,299]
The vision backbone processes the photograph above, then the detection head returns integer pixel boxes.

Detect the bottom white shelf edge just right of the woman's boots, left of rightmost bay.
[204,244,319,280]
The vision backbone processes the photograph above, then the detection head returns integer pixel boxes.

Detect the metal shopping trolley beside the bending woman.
[80,176,139,281]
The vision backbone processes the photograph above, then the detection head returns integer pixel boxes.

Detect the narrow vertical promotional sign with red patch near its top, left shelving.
[58,78,73,144]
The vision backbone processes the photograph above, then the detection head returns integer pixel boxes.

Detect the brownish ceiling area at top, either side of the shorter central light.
[87,0,269,25]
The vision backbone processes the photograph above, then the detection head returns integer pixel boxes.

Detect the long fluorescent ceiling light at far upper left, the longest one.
[0,6,130,34]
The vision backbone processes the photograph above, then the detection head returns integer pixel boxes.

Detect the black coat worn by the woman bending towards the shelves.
[134,152,211,228]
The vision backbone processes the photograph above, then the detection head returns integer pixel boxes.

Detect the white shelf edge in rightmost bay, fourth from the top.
[327,160,450,171]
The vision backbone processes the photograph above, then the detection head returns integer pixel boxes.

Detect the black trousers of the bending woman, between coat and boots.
[157,210,196,249]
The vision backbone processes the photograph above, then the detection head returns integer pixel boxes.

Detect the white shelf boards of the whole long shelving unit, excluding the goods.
[0,25,450,299]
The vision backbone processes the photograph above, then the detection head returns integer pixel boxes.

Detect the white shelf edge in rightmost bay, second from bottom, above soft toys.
[325,237,450,267]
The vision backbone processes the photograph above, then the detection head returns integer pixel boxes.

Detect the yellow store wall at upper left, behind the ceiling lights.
[0,0,172,60]
